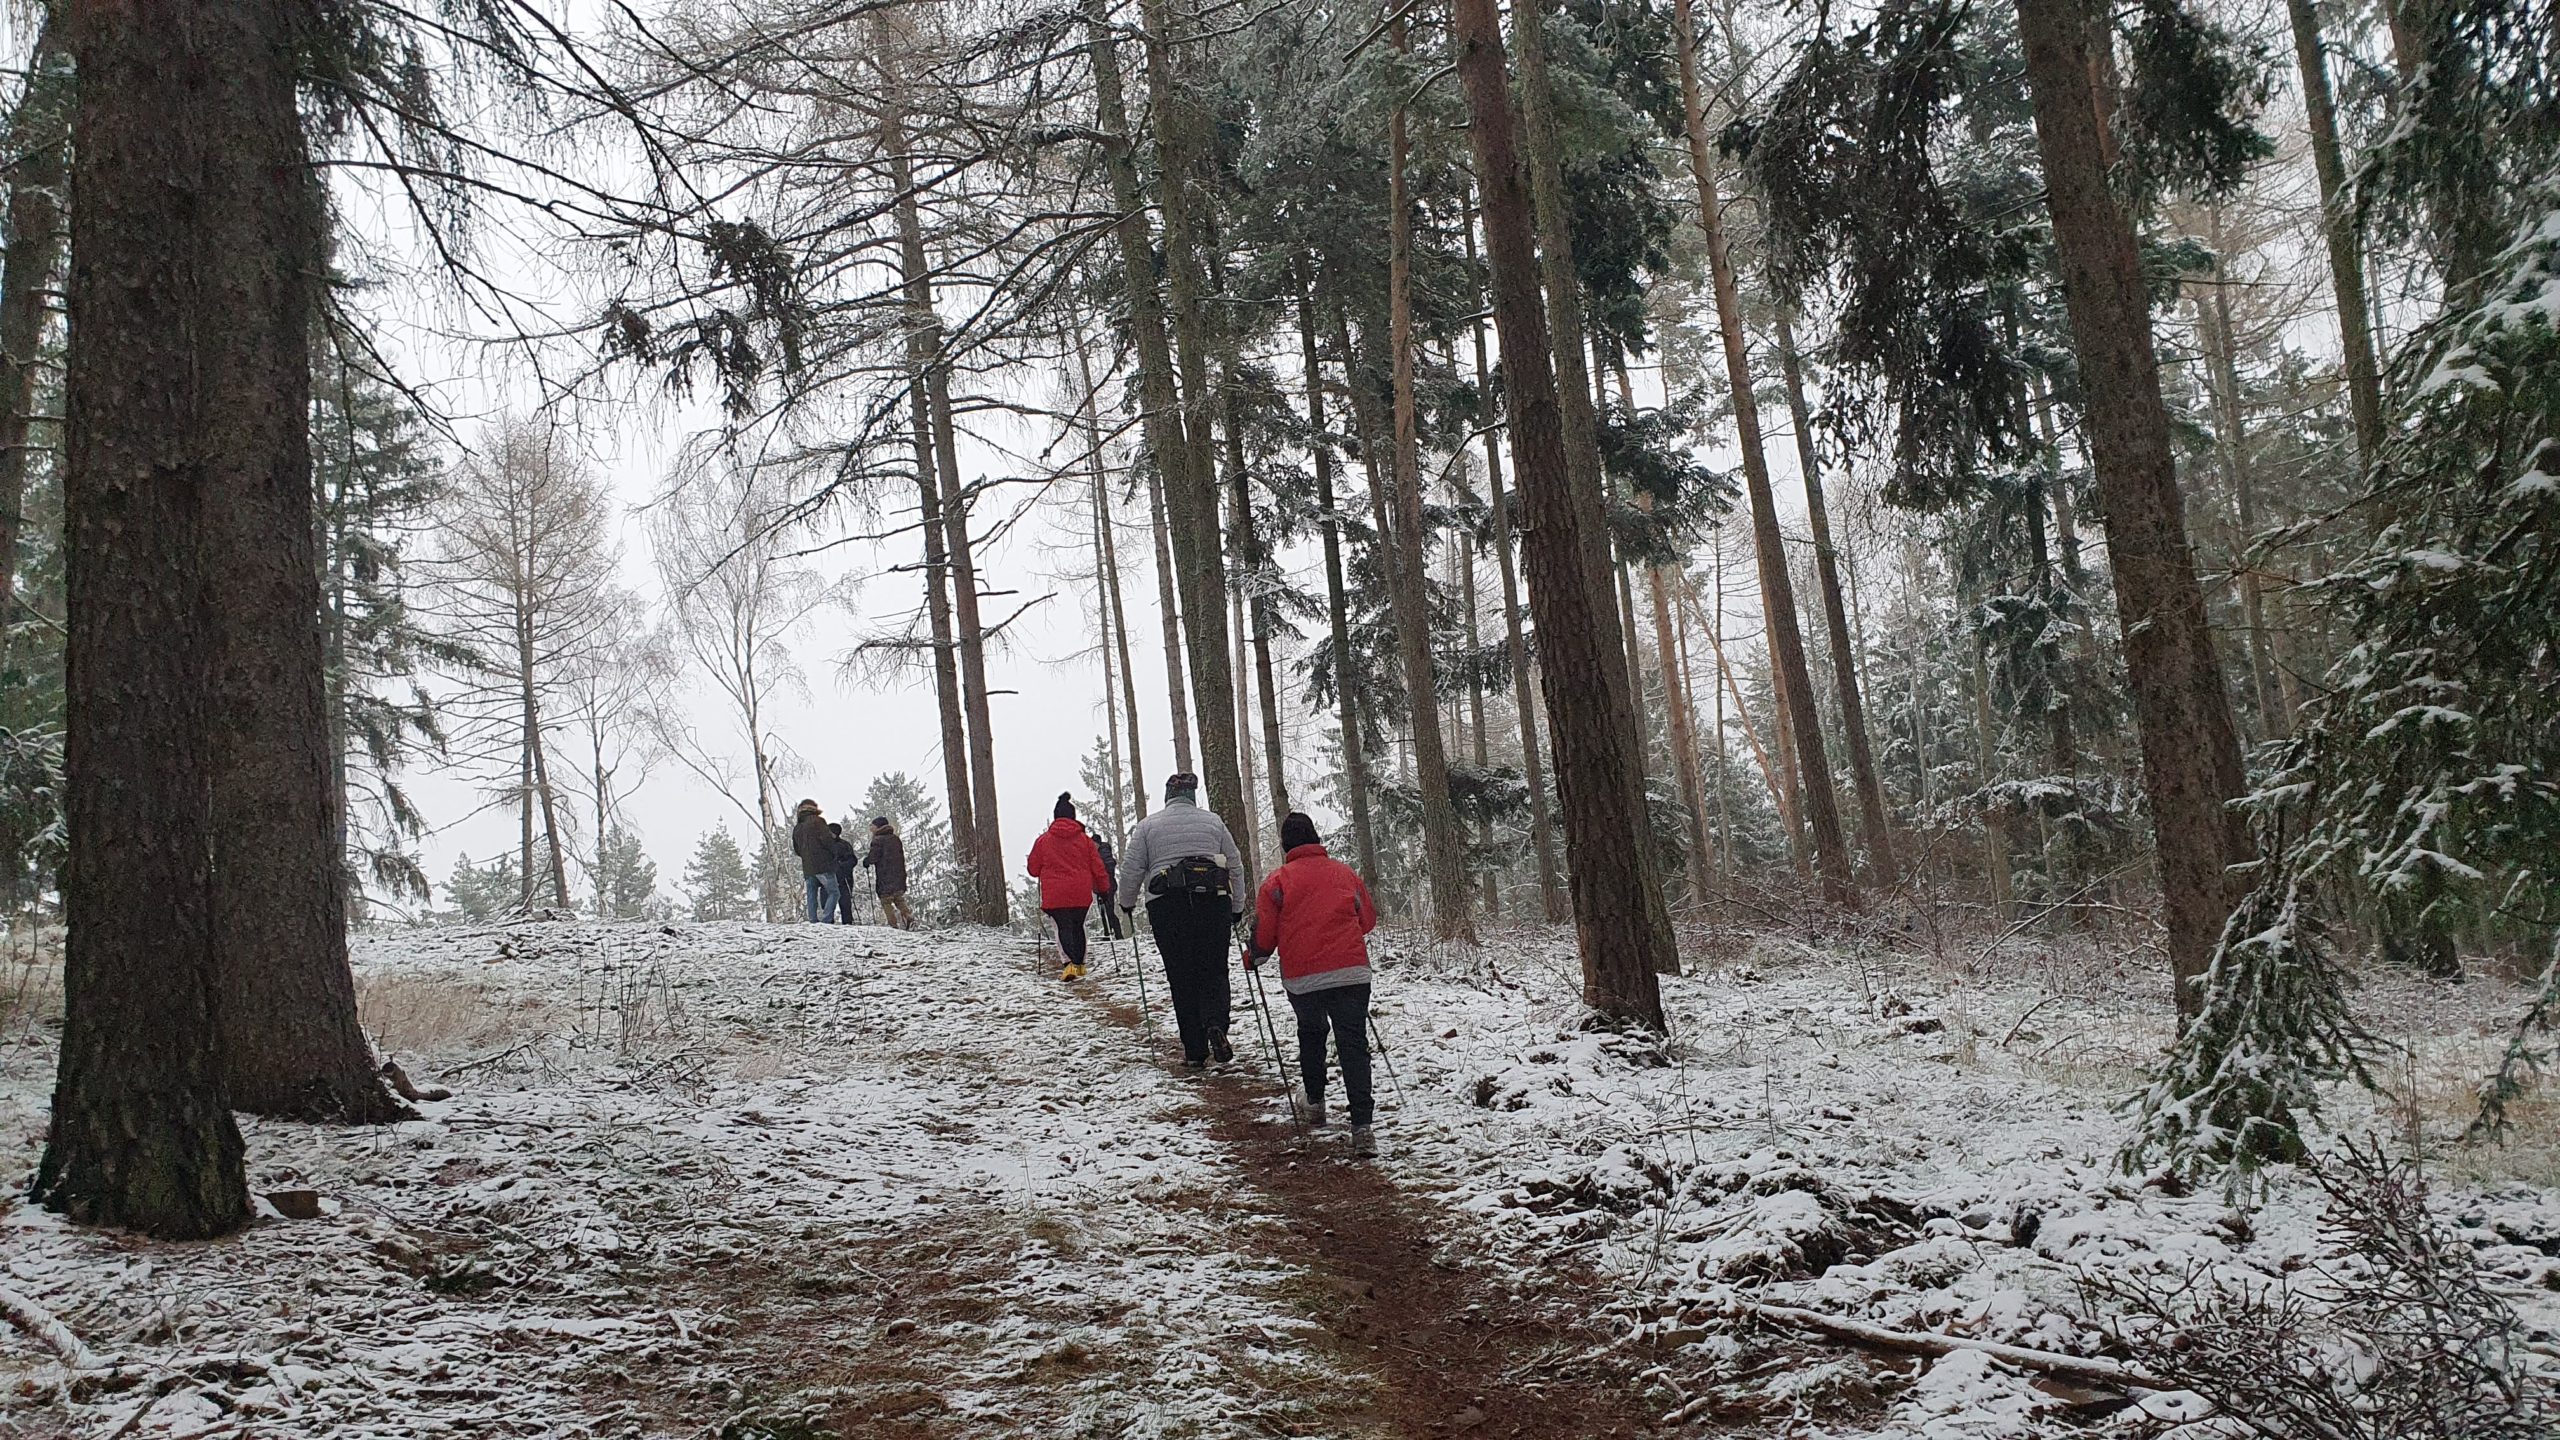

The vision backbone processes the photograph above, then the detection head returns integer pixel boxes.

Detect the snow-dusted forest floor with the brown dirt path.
[0,922,2560,1440]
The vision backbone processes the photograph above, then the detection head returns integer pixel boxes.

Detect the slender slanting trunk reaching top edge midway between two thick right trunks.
[1672,0,1882,902]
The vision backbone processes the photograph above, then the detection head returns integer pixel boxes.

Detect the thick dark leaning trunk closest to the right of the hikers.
[1452,0,1677,1030]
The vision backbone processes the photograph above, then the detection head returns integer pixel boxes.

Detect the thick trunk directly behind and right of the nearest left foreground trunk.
[197,50,407,1122]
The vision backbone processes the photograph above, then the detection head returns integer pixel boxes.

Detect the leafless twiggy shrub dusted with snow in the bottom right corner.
[2081,1145,2560,1440]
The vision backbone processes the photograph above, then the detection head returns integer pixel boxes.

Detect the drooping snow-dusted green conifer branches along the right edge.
[2127,174,2560,1171]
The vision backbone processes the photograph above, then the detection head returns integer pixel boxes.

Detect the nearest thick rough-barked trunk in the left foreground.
[33,0,270,1240]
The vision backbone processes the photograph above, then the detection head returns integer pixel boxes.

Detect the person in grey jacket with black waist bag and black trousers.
[1119,774,1252,1068]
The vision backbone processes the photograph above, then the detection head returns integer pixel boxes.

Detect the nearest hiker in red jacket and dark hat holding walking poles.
[1244,810,1377,1153]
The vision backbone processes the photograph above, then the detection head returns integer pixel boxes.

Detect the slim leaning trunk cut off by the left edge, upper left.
[0,8,72,630]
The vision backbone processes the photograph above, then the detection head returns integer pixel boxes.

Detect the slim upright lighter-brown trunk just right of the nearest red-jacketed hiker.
[1388,30,1475,940]
